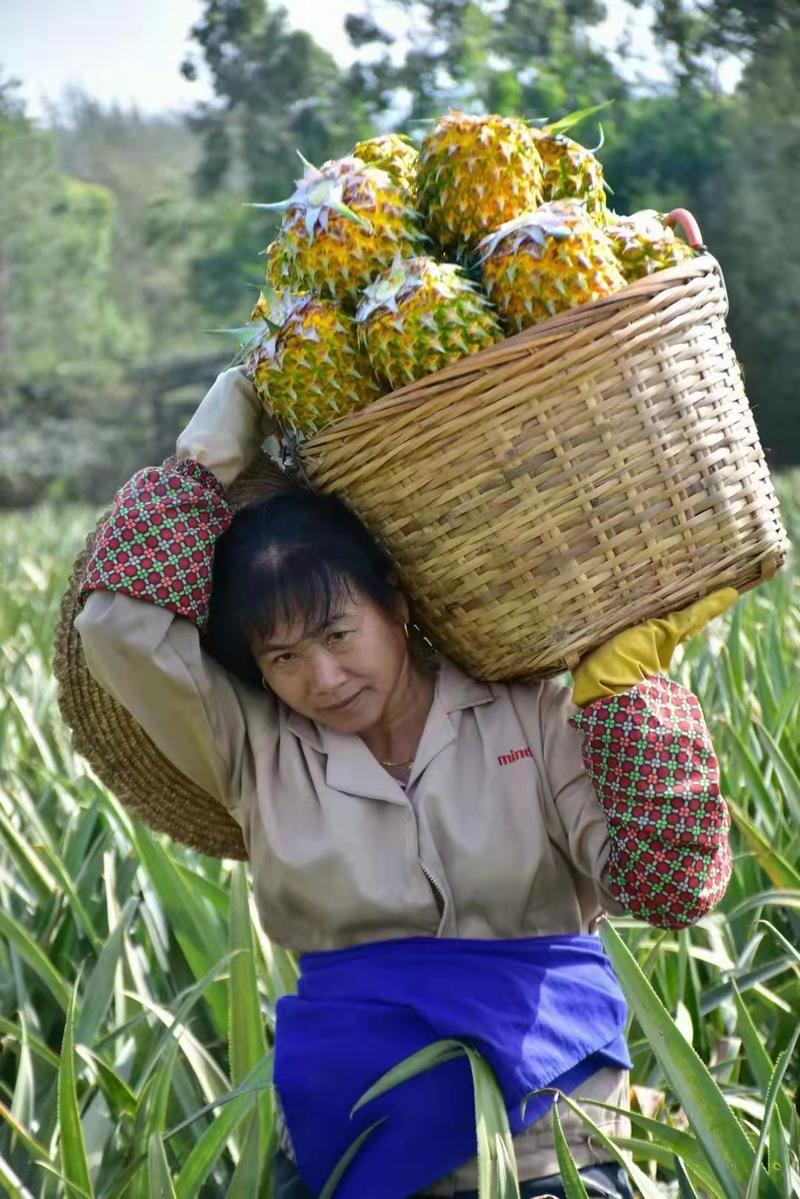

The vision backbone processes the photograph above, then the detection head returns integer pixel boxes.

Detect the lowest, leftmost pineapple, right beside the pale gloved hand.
[245,295,381,436]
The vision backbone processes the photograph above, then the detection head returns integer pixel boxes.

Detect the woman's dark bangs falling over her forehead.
[239,547,354,645]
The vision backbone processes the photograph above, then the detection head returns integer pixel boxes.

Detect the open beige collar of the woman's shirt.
[285,656,495,803]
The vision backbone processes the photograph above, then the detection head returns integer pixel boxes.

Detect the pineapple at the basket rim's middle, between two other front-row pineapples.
[355,258,503,390]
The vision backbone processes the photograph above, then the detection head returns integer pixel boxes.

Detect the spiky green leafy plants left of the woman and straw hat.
[0,507,278,1199]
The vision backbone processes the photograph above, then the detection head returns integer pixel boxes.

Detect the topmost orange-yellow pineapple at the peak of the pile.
[417,109,542,257]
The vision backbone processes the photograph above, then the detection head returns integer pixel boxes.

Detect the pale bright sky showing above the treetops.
[0,0,738,119]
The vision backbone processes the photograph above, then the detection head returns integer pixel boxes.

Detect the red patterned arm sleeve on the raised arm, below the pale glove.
[82,458,233,632]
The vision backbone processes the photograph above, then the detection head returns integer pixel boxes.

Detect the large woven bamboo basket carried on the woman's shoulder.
[300,253,788,680]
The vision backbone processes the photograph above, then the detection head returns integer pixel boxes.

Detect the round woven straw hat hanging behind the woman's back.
[53,453,291,858]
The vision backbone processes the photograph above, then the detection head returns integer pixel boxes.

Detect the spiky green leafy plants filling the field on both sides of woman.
[0,474,800,1199]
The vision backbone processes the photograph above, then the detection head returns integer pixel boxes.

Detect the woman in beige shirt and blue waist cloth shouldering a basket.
[77,368,735,1199]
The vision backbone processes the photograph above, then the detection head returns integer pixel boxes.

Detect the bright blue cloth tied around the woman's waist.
[275,934,631,1199]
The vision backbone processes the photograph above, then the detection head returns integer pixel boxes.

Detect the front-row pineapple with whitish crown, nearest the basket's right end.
[479,200,625,332]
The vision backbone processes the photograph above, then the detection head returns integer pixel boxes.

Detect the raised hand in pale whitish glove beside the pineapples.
[175,367,273,487]
